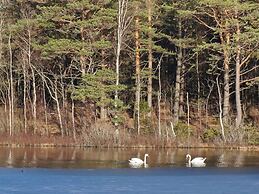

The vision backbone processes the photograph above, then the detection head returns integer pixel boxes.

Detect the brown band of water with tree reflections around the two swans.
[0,147,259,169]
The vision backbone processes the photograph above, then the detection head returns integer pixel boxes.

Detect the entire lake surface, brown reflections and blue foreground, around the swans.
[0,148,259,194]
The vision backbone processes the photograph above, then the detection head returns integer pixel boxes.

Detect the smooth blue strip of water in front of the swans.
[0,168,259,194]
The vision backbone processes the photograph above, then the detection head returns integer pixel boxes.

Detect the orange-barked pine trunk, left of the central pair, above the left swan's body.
[135,7,141,134]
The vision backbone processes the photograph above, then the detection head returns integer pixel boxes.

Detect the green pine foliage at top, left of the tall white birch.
[34,0,116,60]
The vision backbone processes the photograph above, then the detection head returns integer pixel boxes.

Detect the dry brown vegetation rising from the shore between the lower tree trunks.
[0,101,259,147]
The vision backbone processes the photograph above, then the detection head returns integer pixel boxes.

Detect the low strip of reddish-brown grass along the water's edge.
[0,134,259,151]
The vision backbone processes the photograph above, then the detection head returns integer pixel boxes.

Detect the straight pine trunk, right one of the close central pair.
[147,0,153,118]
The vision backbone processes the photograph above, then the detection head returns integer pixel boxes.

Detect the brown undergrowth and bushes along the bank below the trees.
[0,104,259,149]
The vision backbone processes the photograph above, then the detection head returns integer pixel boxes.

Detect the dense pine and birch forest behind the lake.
[0,0,259,146]
